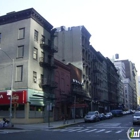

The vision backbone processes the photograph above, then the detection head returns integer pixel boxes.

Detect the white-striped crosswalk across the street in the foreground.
[44,127,127,134]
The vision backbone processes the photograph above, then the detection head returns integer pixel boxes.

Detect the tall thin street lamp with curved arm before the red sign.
[0,48,14,124]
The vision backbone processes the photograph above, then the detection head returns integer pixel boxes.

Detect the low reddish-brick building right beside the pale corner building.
[54,60,72,121]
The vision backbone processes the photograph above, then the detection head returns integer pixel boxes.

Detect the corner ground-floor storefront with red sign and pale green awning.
[0,89,47,123]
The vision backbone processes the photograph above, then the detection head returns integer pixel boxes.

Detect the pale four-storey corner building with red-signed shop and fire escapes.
[0,8,58,123]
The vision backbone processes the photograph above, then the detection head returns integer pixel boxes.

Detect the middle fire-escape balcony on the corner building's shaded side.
[39,57,57,69]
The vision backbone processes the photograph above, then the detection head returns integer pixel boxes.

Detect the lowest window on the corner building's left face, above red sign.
[16,65,23,82]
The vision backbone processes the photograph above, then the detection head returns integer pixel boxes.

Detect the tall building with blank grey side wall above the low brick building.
[54,26,92,106]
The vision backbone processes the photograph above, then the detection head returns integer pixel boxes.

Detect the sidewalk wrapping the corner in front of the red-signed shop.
[9,119,84,130]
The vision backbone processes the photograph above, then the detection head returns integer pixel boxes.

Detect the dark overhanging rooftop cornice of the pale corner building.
[0,8,53,32]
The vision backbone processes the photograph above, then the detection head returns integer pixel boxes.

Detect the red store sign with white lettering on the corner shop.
[0,90,27,104]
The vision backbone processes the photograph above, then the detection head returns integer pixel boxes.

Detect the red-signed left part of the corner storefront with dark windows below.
[0,90,27,123]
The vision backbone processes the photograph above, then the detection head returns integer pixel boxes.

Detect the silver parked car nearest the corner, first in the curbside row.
[84,111,100,122]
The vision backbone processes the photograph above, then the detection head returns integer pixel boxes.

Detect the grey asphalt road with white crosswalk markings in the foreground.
[0,115,140,140]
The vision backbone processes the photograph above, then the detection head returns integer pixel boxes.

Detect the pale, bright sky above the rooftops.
[0,0,140,75]
